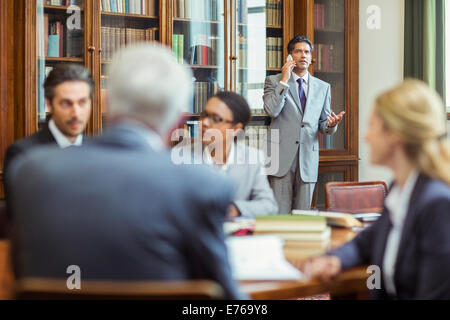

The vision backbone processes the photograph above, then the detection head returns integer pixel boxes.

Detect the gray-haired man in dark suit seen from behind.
[9,44,241,298]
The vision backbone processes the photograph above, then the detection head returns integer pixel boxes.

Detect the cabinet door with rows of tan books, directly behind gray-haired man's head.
[99,0,160,128]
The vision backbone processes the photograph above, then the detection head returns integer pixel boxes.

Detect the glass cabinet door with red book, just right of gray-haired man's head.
[169,0,225,115]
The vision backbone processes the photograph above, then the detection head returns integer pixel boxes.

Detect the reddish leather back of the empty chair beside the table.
[325,181,387,213]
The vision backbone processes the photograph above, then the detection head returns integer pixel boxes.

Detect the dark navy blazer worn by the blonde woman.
[329,174,450,299]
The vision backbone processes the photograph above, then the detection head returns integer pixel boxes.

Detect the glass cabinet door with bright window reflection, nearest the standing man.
[235,0,285,115]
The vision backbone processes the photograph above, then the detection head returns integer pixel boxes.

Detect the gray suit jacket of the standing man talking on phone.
[263,73,337,182]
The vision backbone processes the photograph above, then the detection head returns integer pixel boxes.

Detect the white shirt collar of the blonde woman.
[385,170,419,227]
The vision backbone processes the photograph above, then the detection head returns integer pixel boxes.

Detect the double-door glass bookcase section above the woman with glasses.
[167,0,293,144]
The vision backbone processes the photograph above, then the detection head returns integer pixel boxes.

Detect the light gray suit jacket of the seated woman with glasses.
[173,139,278,217]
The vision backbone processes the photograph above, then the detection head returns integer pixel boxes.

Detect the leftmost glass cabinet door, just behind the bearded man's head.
[36,0,86,128]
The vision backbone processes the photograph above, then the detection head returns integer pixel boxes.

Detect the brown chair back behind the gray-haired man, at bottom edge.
[16,278,224,300]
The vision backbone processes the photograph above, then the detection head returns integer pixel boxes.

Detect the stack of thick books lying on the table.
[254,214,331,252]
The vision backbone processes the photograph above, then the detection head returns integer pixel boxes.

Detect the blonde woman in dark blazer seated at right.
[306,80,450,299]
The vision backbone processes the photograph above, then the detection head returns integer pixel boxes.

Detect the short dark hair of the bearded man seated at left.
[44,64,94,101]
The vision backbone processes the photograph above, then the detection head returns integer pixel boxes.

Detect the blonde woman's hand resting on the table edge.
[303,256,341,282]
